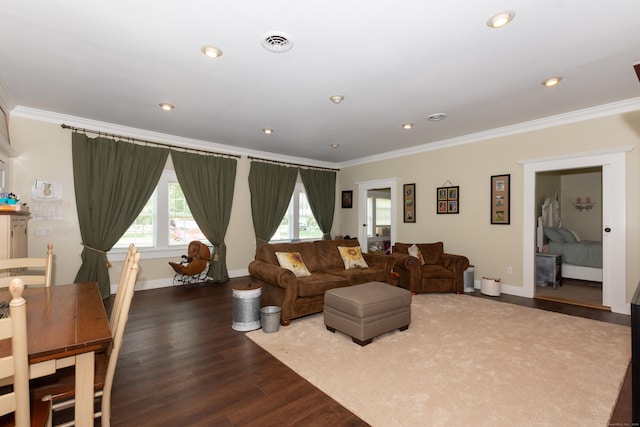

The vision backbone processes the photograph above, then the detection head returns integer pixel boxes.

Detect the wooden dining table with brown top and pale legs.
[0,282,112,426]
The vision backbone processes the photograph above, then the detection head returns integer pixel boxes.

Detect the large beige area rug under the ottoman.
[247,294,631,427]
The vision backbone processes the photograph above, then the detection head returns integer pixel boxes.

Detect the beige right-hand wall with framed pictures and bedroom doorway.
[333,112,640,299]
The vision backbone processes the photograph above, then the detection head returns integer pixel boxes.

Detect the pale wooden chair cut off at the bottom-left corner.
[0,278,51,427]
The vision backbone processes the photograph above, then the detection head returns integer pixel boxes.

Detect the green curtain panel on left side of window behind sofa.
[249,161,298,248]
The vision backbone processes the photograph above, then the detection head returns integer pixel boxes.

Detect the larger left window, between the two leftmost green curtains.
[113,170,211,250]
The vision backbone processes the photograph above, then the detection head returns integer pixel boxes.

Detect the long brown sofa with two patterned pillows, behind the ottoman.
[249,240,394,326]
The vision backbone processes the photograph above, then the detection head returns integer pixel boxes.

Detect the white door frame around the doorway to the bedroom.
[519,147,632,314]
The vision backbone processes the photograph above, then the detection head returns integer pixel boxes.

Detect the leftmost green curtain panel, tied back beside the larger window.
[71,133,169,298]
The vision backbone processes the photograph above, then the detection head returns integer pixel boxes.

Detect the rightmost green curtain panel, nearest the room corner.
[300,168,336,240]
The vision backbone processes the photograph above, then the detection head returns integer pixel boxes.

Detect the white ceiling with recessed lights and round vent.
[0,0,640,164]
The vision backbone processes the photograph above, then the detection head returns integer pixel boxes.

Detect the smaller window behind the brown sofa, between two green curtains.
[271,182,322,242]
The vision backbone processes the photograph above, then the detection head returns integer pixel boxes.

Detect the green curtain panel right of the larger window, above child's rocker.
[171,151,238,282]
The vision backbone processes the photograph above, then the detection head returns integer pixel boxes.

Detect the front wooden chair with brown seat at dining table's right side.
[32,253,140,427]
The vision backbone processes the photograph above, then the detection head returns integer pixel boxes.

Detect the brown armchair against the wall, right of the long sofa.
[391,242,469,293]
